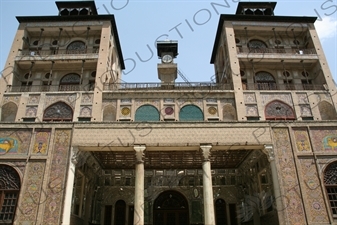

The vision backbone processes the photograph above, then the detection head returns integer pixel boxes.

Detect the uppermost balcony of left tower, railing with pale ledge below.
[15,48,99,60]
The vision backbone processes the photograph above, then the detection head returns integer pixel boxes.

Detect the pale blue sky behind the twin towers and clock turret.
[0,0,337,82]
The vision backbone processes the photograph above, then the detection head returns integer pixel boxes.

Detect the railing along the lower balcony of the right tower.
[243,83,325,91]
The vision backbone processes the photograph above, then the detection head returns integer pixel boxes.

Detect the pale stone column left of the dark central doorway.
[133,145,146,225]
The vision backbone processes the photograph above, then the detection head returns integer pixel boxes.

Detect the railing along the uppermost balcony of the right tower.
[237,47,316,55]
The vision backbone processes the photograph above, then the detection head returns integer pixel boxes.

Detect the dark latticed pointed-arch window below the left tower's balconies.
[43,102,73,121]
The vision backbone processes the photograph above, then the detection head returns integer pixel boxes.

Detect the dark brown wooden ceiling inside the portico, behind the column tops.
[92,150,253,169]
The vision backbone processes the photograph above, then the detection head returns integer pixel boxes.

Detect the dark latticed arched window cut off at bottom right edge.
[324,161,337,218]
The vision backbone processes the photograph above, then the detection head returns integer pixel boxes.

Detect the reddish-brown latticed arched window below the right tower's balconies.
[265,100,296,120]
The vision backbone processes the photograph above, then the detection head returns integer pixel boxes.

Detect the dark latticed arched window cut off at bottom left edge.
[0,165,21,224]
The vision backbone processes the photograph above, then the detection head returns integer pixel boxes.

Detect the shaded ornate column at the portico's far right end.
[262,145,282,214]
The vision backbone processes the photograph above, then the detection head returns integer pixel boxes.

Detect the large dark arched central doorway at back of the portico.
[153,191,189,225]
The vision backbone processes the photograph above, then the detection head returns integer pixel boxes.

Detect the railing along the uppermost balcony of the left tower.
[18,48,99,57]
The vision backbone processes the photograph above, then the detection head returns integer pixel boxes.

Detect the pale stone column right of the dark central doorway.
[200,145,215,225]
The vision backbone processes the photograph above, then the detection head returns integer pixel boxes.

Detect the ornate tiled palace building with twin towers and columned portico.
[0,1,337,225]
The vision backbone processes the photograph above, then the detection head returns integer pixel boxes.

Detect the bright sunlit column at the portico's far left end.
[62,146,78,224]
